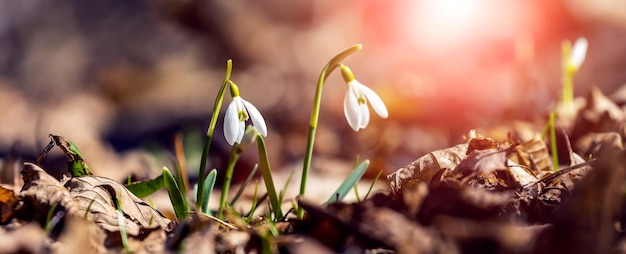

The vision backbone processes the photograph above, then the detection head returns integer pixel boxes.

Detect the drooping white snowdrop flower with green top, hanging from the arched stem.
[340,64,389,131]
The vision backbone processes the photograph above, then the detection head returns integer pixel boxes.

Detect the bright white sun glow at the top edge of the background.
[397,0,531,54]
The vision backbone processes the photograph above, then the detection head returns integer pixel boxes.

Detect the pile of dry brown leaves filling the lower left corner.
[0,163,173,252]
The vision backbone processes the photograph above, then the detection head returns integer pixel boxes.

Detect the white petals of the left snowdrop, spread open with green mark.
[224,96,267,145]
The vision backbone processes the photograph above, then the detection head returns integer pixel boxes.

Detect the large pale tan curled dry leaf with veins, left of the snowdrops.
[18,163,170,236]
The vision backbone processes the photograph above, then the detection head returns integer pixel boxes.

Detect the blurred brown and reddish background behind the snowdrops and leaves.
[0,0,626,191]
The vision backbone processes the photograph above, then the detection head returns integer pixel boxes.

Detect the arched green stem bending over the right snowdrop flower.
[297,44,363,219]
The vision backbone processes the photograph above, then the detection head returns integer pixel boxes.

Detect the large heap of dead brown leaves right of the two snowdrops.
[295,88,626,253]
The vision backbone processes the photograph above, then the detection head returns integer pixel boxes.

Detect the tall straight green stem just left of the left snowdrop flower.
[196,59,233,208]
